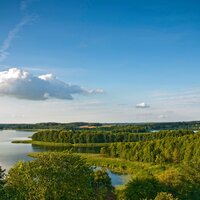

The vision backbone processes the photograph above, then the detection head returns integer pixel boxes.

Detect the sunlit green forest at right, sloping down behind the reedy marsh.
[101,133,200,163]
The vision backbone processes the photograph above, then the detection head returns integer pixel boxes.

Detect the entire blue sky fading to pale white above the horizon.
[0,0,200,123]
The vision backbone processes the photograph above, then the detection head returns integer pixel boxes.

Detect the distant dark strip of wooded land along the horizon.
[0,121,200,133]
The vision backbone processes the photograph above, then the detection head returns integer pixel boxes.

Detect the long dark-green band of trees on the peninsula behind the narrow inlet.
[32,129,194,144]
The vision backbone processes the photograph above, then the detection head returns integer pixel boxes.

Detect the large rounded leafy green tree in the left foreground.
[5,152,108,200]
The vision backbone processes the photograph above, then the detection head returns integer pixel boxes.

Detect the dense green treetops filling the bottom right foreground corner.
[119,162,200,200]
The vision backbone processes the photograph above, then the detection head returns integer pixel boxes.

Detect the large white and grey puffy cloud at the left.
[0,68,103,100]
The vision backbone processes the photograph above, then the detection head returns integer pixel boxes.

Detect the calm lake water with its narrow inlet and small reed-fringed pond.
[0,130,130,186]
